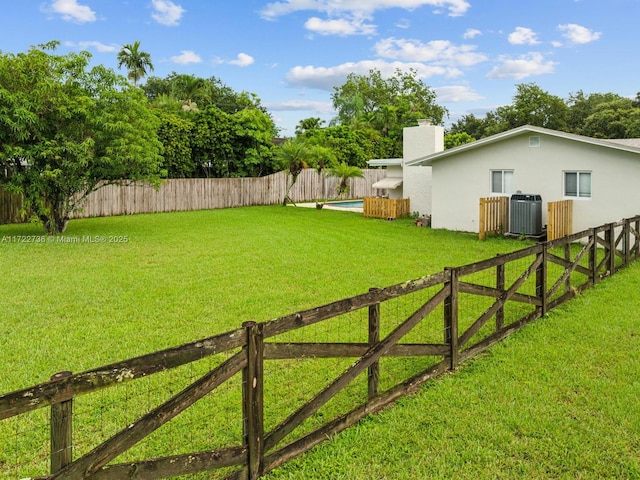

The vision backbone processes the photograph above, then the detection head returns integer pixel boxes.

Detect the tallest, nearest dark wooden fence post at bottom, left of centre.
[242,322,264,480]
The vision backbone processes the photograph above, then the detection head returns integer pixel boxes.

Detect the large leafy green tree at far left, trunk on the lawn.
[0,42,162,234]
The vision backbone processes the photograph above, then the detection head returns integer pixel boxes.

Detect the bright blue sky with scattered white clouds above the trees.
[0,0,640,136]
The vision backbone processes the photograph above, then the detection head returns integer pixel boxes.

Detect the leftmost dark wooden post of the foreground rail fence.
[50,371,73,474]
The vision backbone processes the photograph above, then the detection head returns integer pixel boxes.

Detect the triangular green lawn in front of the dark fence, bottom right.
[267,264,640,480]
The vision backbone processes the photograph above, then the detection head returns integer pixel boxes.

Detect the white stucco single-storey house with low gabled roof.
[408,125,640,232]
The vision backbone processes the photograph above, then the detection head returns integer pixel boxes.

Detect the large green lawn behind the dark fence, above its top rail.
[0,207,523,392]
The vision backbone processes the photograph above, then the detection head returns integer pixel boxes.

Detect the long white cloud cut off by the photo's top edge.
[260,0,471,20]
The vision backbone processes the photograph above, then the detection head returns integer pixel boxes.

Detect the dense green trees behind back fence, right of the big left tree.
[141,72,278,177]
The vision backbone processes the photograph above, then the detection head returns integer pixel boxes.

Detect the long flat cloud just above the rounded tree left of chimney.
[287,60,462,91]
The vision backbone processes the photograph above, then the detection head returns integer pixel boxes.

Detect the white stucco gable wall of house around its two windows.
[432,132,640,232]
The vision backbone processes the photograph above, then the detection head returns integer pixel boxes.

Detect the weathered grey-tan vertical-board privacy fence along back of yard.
[0,169,385,223]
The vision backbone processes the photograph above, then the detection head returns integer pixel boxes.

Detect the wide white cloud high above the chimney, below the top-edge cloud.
[374,37,487,67]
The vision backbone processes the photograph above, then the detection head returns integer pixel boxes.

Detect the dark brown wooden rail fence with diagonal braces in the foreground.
[0,216,640,479]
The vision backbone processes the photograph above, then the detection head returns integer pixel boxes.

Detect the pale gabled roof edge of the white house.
[405,125,640,167]
